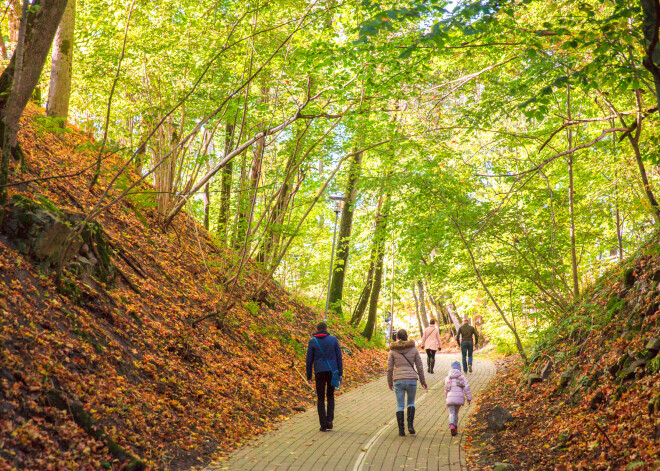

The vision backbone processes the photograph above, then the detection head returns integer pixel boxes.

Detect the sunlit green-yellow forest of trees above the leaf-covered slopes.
[0,0,660,358]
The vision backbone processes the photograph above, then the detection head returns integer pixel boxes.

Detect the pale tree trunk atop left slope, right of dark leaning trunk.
[46,0,76,127]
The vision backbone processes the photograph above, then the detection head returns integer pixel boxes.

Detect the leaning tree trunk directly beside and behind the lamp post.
[329,152,362,316]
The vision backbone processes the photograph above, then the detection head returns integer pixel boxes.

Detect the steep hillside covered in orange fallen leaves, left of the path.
[0,108,383,470]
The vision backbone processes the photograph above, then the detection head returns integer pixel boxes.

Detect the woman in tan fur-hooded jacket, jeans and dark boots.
[387,329,427,437]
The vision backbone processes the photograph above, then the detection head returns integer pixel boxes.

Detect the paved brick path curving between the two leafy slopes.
[206,354,495,471]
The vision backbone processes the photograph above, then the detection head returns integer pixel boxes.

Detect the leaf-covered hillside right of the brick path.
[469,242,660,471]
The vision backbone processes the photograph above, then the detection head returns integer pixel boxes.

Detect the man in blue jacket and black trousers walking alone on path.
[306,322,344,432]
